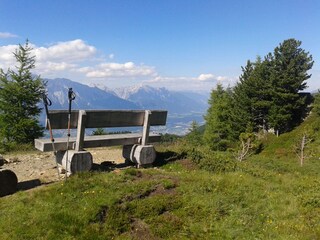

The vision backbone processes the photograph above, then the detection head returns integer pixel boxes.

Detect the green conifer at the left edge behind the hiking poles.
[0,40,45,144]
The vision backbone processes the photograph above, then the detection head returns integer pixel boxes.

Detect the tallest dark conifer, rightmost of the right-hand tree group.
[269,39,314,133]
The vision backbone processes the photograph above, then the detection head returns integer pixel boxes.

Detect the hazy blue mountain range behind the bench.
[40,78,209,135]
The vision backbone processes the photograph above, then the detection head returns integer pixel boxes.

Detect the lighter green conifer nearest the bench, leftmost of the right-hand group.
[203,84,233,150]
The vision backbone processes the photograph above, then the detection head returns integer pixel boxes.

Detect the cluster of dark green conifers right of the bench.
[204,39,314,153]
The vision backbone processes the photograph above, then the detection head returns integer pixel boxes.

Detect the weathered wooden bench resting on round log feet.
[35,110,167,173]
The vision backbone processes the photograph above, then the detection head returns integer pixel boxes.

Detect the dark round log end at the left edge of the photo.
[0,169,18,197]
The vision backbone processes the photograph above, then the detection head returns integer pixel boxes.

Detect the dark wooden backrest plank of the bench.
[47,110,167,129]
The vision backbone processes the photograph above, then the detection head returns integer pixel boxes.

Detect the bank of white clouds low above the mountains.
[0,39,235,91]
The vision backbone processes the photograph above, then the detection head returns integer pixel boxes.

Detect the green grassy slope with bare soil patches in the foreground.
[0,116,320,239]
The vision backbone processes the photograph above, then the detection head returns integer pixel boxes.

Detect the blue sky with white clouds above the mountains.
[0,0,320,91]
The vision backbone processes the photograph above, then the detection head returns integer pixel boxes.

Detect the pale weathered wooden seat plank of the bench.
[35,133,161,152]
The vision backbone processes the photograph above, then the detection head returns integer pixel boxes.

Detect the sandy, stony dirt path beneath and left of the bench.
[2,147,124,183]
